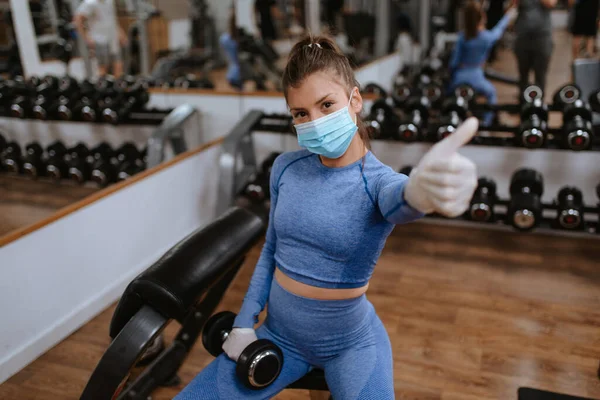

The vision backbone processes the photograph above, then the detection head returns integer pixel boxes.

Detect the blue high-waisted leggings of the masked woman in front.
[175,279,394,400]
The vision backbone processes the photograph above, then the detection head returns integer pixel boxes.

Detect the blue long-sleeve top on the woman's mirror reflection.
[450,15,510,71]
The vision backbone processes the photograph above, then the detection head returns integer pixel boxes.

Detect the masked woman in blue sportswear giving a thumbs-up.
[176,37,477,400]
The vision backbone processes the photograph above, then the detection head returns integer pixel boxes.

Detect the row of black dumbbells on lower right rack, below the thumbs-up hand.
[399,166,600,231]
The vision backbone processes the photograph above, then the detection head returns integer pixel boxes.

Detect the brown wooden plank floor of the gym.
[0,29,600,400]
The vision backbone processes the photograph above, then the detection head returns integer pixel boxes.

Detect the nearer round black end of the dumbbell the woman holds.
[236,339,283,390]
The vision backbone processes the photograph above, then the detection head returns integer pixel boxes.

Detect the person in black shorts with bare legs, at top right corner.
[569,0,600,60]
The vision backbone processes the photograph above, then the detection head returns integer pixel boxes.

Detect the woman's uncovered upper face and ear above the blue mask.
[287,72,362,125]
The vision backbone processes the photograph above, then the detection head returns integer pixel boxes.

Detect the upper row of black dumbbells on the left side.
[0,75,150,124]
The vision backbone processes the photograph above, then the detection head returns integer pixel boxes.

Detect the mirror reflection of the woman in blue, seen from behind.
[450,1,516,126]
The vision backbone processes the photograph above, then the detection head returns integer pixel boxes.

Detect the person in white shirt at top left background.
[73,0,127,77]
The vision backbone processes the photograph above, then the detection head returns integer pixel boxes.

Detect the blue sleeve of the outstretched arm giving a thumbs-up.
[376,168,425,224]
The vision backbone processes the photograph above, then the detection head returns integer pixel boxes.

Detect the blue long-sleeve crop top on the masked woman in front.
[234,150,423,328]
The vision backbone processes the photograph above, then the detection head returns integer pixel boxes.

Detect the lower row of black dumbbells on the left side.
[0,136,146,187]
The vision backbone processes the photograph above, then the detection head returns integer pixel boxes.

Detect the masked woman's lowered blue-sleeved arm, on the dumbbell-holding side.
[233,159,282,328]
